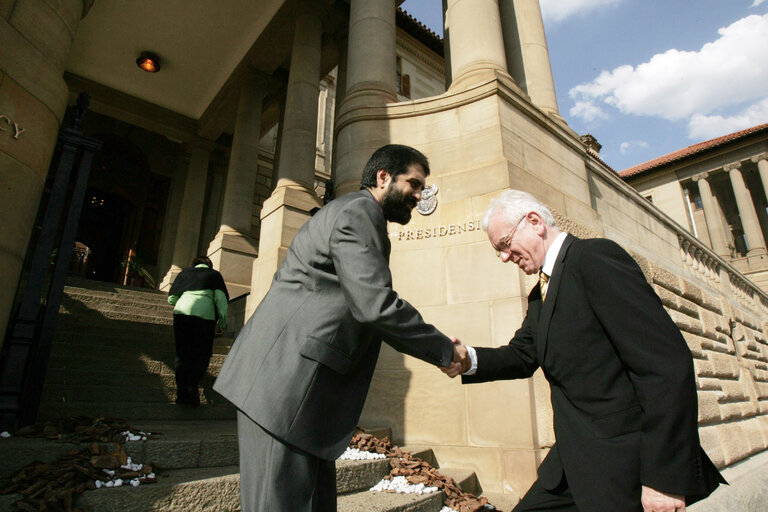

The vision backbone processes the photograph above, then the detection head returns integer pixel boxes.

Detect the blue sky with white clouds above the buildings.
[401,0,768,171]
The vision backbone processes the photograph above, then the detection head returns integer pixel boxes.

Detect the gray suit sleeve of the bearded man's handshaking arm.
[330,197,453,366]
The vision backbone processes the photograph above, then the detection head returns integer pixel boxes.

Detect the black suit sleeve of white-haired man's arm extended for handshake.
[461,306,539,384]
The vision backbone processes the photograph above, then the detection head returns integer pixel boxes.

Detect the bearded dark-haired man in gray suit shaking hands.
[214,145,463,512]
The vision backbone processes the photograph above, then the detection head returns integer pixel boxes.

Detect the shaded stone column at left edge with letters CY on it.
[0,0,90,344]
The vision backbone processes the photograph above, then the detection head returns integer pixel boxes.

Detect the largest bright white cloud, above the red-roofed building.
[569,14,768,128]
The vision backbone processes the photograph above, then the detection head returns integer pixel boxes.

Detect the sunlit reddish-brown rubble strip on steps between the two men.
[349,429,501,512]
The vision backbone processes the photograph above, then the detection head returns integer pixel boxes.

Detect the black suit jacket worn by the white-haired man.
[463,235,722,512]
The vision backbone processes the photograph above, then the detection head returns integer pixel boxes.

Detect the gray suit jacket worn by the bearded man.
[214,190,453,460]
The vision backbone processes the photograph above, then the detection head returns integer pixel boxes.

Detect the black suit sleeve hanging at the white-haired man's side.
[579,239,701,495]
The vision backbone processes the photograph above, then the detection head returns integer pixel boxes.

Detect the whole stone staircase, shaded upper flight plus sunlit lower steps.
[0,280,516,512]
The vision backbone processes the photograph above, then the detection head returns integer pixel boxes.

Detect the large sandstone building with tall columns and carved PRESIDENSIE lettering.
[0,0,768,502]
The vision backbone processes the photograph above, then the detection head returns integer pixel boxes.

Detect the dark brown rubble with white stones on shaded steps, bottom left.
[0,418,158,512]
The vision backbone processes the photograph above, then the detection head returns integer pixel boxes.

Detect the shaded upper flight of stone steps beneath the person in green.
[39,279,235,421]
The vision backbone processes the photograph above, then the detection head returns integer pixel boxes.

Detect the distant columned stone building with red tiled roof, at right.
[619,124,768,291]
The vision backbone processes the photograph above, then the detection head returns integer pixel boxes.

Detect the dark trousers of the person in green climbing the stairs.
[173,314,216,405]
